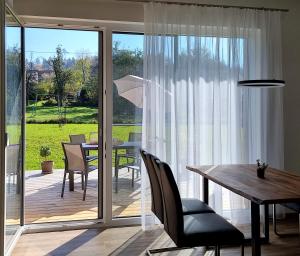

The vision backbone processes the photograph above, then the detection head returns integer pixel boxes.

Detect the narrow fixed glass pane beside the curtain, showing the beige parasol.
[112,33,144,218]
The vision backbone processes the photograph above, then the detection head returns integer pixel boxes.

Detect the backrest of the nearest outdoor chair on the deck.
[62,143,87,172]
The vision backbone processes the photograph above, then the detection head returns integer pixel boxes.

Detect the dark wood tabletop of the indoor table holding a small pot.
[187,165,300,204]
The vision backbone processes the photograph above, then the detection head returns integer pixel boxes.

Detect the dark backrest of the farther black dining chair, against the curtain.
[140,149,164,223]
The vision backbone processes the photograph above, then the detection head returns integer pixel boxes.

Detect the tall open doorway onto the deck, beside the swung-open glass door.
[25,28,103,223]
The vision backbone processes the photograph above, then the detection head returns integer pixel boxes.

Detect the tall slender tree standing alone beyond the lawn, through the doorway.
[50,46,72,106]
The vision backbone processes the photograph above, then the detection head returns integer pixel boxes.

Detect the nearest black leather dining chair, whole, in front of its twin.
[148,159,244,256]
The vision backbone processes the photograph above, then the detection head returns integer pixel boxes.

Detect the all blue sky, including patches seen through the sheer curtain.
[6,27,243,66]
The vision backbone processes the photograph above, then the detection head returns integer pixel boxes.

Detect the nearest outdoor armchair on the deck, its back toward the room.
[61,143,97,201]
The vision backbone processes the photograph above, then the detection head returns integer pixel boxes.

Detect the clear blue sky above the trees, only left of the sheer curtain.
[23,28,143,59]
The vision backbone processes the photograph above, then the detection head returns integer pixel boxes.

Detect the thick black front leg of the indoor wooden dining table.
[251,202,261,256]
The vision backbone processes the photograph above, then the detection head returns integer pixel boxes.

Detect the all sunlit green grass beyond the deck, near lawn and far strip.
[25,101,141,170]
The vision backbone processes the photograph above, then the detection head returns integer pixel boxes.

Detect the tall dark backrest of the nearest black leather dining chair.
[156,160,183,246]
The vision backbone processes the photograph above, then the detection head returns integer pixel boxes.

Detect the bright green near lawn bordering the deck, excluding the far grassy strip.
[26,124,141,170]
